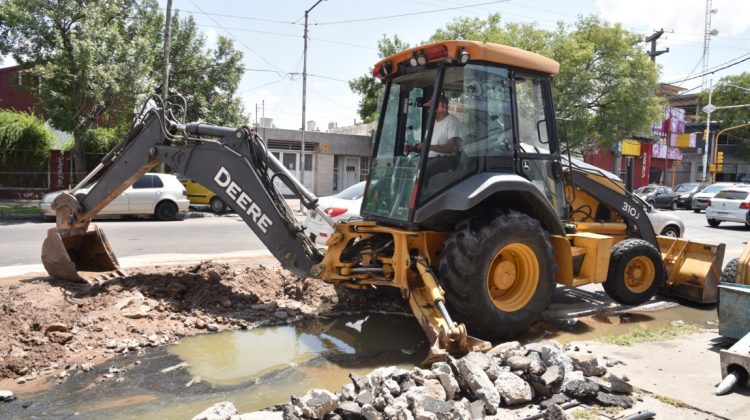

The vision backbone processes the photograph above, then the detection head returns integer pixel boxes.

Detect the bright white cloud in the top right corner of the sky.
[596,0,750,36]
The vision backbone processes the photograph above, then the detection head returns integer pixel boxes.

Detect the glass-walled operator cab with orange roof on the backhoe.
[362,41,566,226]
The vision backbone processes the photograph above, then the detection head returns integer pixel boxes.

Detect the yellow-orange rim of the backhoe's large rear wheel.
[487,243,539,312]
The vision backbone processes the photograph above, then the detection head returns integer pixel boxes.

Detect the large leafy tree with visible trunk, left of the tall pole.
[0,0,163,179]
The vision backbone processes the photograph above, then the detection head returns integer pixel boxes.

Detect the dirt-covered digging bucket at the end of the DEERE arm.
[42,225,124,283]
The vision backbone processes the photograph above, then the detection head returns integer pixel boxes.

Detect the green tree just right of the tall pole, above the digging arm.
[164,13,248,127]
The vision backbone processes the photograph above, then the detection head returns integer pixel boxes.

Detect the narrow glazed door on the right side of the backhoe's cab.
[513,74,567,219]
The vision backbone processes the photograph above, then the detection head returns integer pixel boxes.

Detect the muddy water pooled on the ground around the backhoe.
[0,306,717,419]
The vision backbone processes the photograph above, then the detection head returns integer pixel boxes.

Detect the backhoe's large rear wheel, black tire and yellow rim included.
[439,211,556,340]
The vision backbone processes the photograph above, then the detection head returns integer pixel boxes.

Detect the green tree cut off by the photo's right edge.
[699,72,750,159]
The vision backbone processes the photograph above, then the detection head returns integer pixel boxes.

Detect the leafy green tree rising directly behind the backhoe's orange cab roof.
[431,14,661,147]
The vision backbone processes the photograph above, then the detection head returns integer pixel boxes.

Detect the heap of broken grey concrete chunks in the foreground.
[197,342,633,420]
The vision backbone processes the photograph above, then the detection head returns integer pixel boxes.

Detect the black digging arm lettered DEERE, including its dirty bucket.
[42,99,322,280]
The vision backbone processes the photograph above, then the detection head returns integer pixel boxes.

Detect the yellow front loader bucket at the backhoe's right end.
[657,236,725,303]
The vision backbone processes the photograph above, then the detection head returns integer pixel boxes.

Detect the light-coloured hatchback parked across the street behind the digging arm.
[39,173,190,220]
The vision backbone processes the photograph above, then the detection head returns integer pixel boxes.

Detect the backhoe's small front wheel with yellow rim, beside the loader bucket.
[603,239,664,305]
